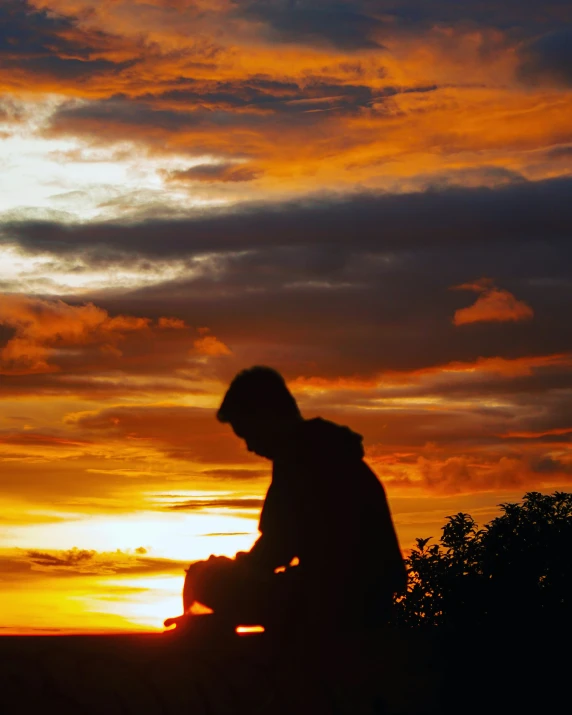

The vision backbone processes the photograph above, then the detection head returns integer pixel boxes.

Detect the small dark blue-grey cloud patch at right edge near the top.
[518,28,572,87]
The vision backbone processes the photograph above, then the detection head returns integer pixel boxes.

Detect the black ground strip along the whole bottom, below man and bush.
[0,627,570,715]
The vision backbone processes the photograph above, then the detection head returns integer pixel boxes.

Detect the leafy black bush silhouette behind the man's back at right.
[396,492,572,630]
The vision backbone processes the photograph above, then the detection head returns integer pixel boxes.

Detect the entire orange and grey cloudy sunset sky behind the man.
[0,0,572,633]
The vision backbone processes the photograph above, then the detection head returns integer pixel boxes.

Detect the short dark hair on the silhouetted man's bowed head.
[217,365,301,423]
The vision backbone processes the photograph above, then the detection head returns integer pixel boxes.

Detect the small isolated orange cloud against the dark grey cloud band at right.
[453,278,534,325]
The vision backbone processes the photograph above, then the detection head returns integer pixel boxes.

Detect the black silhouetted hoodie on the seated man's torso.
[250,418,405,595]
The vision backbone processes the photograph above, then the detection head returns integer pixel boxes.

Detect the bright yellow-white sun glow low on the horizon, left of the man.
[0,506,257,632]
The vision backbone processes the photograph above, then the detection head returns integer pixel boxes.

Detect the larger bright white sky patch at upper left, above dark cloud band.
[0,103,226,223]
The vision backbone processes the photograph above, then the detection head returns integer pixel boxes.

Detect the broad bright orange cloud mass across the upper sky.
[0,0,572,197]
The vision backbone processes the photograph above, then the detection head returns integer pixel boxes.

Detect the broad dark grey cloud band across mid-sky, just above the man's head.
[4,179,572,381]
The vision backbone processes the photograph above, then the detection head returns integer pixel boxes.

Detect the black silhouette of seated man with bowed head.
[166,367,406,629]
